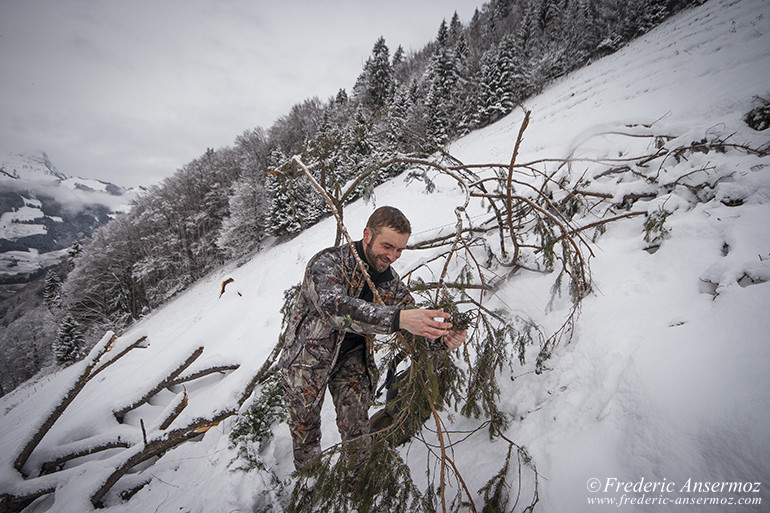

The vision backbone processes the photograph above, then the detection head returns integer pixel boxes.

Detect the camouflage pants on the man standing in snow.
[281,341,373,469]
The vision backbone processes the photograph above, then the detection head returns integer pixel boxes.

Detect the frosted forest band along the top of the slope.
[0,0,700,394]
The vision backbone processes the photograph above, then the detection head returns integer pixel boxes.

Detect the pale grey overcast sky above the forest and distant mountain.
[0,0,484,186]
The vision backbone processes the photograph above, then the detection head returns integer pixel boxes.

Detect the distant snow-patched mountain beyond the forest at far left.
[0,151,137,299]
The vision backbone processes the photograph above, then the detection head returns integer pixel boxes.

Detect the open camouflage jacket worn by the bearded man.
[279,244,414,386]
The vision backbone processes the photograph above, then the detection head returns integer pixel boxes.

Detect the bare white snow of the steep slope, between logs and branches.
[0,0,770,512]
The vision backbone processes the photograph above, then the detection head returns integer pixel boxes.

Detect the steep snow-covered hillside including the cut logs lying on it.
[0,0,770,513]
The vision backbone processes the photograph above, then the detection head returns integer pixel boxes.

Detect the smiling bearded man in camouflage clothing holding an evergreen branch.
[280,207,465,469]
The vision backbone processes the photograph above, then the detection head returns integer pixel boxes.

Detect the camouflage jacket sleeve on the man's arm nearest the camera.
[304,249,402,335]
